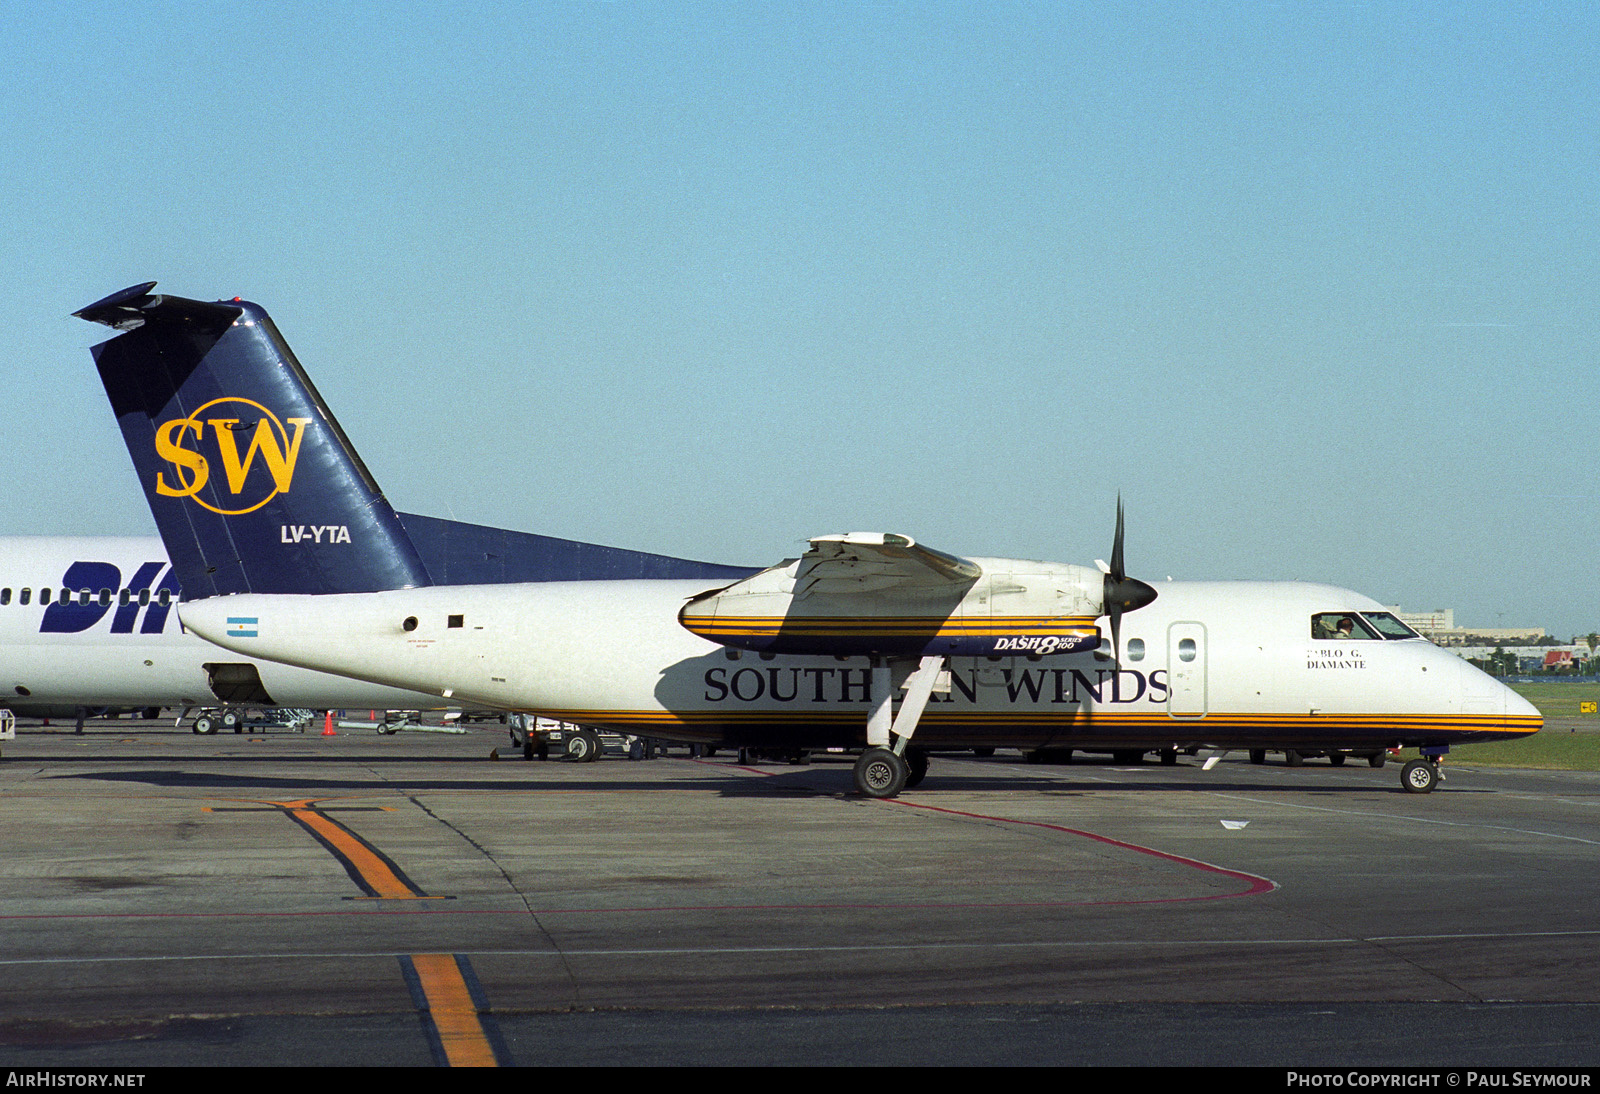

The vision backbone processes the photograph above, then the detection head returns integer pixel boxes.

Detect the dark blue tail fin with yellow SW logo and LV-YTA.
[74,281,750,600]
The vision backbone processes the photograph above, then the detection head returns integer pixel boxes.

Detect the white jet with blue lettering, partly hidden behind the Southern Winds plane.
[0,536,459,733]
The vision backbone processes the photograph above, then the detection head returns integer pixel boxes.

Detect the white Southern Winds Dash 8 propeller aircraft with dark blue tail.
[78,283,1541,797]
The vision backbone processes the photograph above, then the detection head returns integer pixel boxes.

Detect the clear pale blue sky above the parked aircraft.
[0,0,1600,637]
